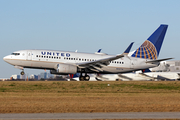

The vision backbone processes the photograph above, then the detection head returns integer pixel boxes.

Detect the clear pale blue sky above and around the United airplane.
[0,0,180,78]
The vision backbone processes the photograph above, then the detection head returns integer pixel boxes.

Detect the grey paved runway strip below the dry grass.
[0,112,180,119]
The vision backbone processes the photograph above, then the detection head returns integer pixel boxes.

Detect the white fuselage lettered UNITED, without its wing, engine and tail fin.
[3,50,157,73]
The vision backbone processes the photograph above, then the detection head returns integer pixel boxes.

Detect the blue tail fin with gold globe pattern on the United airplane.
[131,25,168,60]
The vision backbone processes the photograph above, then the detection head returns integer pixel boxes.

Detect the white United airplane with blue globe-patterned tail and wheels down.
[3,24,172,81]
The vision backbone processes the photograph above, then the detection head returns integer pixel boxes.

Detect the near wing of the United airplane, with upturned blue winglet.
[76,42,134,72]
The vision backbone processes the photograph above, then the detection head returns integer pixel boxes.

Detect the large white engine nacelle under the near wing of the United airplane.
[52,64,77,74]
